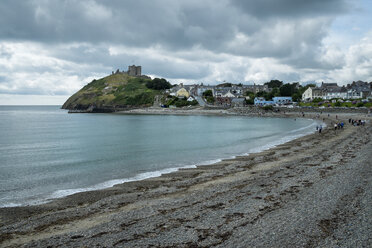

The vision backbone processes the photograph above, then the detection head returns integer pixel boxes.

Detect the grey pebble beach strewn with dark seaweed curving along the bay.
[0,110,372,247]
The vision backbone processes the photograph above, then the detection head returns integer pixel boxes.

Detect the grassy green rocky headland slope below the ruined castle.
[62,73,159,112]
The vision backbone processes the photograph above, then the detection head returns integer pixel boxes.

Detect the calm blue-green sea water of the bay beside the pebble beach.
[0,106,317,207]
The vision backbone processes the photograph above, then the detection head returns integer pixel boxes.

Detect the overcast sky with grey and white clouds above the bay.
[0,0,372,105]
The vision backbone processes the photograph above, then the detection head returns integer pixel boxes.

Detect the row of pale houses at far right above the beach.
[302,81,371,101]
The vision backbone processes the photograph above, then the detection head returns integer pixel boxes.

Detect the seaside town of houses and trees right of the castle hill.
[166,77,372,107]
